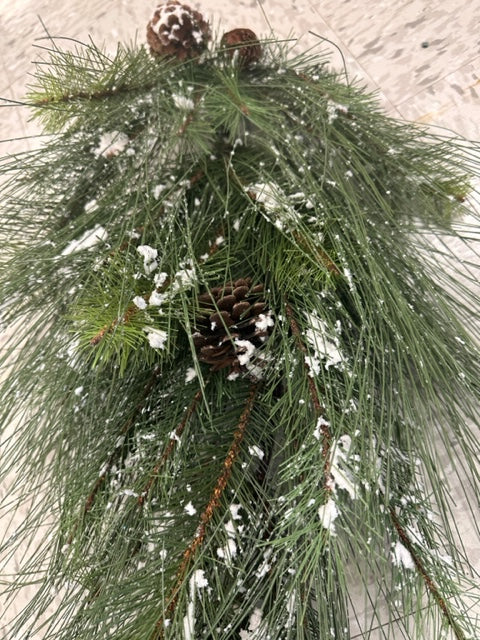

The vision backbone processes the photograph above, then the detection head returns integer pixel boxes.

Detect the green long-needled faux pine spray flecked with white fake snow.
[0,6,480,640]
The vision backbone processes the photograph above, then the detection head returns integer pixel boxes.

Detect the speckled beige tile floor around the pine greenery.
[0,0,480,640]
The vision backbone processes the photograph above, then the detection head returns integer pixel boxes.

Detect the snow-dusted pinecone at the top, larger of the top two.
[147,0,210,60]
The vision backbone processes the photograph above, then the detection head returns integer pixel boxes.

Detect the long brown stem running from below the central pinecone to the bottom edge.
[150,383,258,640]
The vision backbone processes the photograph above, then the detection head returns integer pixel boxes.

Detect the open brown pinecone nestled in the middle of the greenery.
[193,278,273,373]
